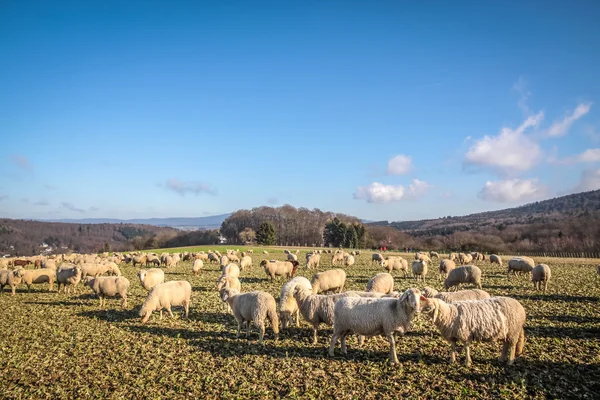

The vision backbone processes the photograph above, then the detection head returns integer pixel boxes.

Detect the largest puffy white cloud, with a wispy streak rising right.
[465,112,544,175]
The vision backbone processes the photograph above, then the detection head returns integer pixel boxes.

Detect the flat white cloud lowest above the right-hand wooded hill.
[479,179,546,203]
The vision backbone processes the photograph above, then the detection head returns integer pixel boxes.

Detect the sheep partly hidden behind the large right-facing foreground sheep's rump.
[294,285,357,344]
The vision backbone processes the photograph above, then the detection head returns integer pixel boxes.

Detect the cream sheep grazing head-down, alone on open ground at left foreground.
[139,281,192,324]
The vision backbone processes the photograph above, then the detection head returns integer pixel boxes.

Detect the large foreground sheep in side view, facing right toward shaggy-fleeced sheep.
[329,288,421,365]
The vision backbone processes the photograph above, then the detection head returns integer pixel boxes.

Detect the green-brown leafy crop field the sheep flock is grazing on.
[0,247,600,399]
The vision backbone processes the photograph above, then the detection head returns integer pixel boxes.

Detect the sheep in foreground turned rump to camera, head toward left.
[221,288,279,345]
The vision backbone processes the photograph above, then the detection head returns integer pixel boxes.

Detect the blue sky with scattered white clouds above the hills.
[0,0,600,221]
